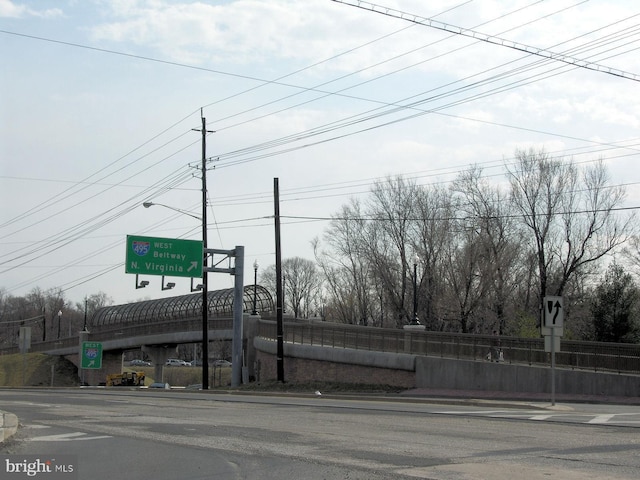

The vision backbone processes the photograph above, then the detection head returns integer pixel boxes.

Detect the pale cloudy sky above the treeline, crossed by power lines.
[0,0,640,303]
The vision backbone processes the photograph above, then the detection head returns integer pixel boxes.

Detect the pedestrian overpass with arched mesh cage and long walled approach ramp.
[13,285,640,397]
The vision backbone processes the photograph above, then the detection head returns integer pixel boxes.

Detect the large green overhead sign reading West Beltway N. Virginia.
[125,235,203,277]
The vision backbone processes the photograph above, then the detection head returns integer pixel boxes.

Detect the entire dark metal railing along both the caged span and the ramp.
[2,317,640,374]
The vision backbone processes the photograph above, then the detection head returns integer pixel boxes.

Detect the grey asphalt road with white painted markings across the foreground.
[0,389,640,480]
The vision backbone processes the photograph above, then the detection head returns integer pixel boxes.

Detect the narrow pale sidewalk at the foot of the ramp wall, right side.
[400,388,640,406]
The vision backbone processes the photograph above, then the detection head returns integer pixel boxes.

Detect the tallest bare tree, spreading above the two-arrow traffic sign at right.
[507,150,631,322]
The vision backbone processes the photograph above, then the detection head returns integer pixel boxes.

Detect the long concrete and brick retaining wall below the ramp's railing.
[250,337,640,397]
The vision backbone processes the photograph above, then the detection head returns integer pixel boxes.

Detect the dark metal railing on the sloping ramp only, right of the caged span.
[259,320,640,374]
